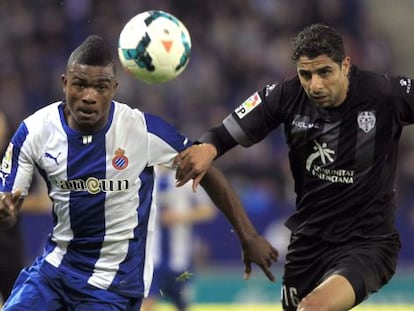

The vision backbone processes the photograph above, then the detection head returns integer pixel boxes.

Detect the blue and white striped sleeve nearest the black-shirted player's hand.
[145,113,192,168]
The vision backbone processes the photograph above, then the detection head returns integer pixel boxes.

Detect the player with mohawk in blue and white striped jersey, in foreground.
[0,35,277,311]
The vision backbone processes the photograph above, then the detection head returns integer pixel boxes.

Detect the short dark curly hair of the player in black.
[291,24,345,64]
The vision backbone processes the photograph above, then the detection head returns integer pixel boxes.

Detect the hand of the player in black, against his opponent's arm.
[174,143,217,191]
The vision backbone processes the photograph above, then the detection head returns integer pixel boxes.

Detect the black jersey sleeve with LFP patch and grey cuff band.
[223,84,283,147]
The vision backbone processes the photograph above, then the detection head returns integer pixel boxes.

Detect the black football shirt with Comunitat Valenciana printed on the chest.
[223,66,414,241]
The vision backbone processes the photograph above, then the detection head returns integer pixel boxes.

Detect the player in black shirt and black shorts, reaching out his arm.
[176,24,404,311]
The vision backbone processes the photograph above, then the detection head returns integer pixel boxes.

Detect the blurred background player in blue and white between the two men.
[142,166,216,311]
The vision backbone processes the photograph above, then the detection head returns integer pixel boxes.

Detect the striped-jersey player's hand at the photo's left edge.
[0,190,23,230]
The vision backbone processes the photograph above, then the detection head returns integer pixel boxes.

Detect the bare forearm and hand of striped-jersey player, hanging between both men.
[201,165,278,282]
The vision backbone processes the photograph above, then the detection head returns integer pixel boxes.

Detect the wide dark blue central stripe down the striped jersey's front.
[65,132,106,273]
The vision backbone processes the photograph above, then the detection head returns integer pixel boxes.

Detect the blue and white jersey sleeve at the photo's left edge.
[0,123,34,196]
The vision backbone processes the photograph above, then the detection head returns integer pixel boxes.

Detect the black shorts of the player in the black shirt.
[282,233,401,311]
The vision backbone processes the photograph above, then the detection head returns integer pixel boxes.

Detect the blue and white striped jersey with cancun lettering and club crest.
[0,101,191,297]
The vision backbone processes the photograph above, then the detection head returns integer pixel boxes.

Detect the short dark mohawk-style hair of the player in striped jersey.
[67,35,116,73]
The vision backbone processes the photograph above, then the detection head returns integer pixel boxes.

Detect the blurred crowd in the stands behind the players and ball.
[0,0,414,268]
